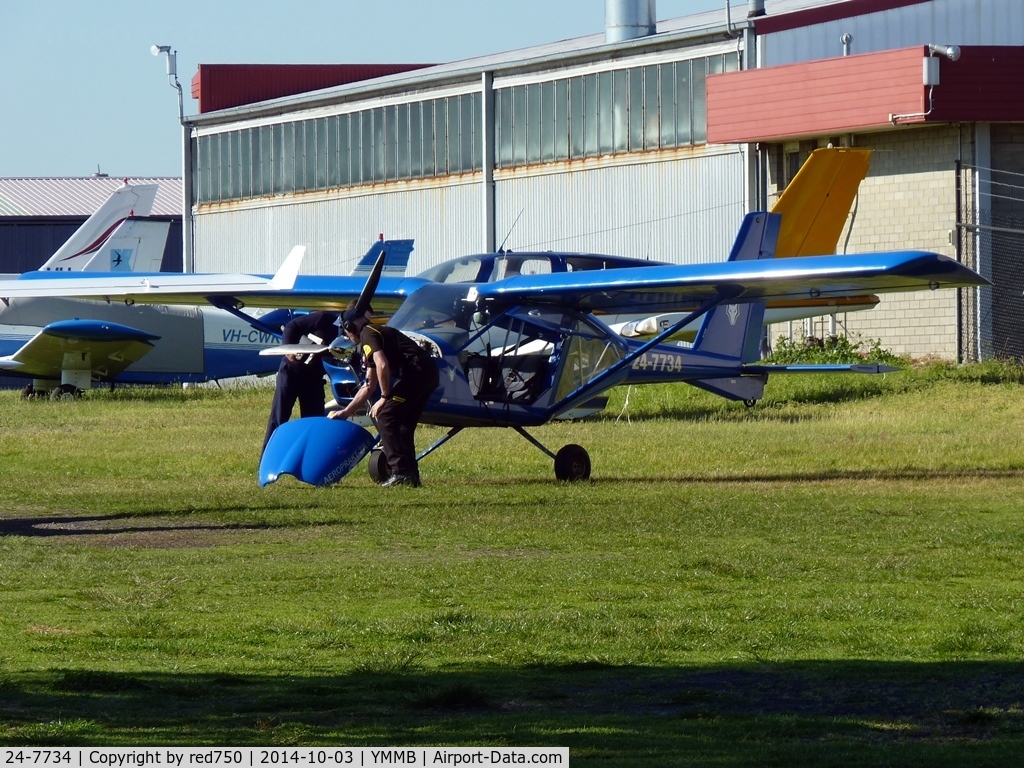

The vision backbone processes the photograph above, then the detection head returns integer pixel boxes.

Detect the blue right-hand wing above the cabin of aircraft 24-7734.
[475,251,989,312]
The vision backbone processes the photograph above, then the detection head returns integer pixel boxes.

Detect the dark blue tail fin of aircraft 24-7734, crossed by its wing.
[693,213,779,364]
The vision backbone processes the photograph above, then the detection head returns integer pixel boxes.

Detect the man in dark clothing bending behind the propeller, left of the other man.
[263,311,338,450]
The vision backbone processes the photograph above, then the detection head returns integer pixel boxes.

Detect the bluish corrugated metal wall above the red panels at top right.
[758,0,1024,67]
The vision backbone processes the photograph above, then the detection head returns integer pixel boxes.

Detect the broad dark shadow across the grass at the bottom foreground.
[0,658,1024,766]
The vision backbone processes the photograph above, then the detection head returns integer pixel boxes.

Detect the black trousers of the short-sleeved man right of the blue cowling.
[377,360,438,476]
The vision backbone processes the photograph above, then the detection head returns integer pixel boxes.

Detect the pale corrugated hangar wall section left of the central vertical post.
[196,174,483,274]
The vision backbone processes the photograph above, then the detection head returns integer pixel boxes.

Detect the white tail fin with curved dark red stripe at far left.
[39,184,158,272]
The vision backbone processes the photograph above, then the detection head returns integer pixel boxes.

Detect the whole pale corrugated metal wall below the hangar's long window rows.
[196,147,745,274]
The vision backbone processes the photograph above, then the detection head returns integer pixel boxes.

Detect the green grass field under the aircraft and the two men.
[0,365,1024,767]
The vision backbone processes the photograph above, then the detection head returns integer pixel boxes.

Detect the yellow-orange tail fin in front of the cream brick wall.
[771,146,871,257]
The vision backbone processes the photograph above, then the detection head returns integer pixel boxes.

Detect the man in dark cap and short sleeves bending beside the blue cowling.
[331,309,438,487]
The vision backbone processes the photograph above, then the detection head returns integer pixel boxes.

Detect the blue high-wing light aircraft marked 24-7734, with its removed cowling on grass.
[0,201,987,485]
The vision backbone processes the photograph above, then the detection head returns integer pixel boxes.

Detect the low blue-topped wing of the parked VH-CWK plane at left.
[0,319,160,380]
